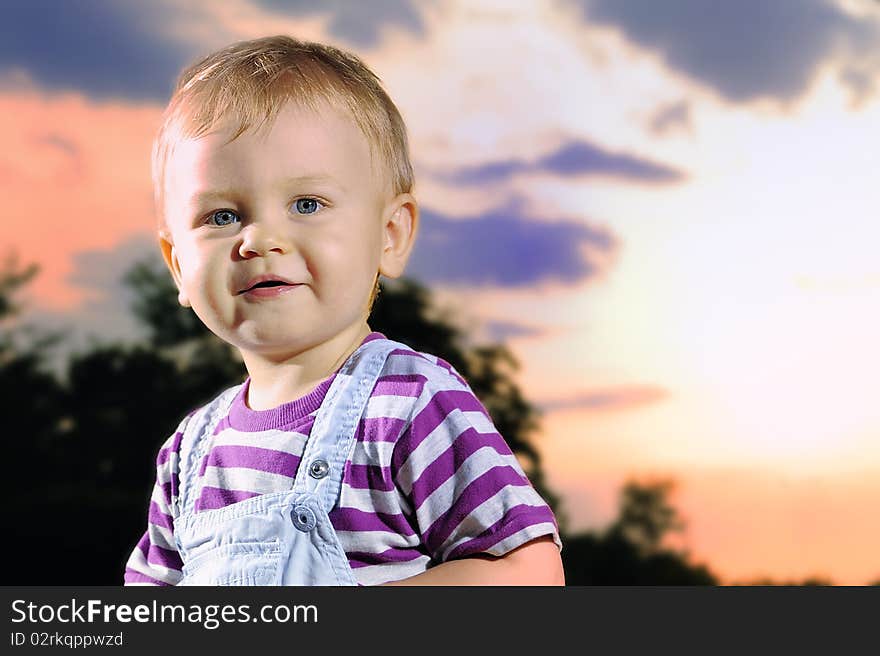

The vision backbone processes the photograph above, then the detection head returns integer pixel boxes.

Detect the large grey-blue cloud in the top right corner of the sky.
[571,0,880,102]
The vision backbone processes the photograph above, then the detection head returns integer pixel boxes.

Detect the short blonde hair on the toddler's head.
[152,35,414,306]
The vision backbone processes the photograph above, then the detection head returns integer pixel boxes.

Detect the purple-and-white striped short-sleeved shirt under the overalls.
[125,332,561,585]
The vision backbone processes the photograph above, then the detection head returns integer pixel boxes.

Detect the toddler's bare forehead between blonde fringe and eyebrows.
[166,103,381,209]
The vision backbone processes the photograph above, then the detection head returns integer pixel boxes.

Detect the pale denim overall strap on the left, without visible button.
[172,383,243,517]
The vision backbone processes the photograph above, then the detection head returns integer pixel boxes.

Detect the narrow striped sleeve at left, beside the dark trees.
[125,415,191,585]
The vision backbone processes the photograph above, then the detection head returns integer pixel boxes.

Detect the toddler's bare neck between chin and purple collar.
[242,321,371,410]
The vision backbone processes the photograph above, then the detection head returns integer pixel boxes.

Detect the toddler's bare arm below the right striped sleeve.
[385,535,565,585]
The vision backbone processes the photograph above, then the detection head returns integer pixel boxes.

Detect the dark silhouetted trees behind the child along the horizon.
[0,258,864,585]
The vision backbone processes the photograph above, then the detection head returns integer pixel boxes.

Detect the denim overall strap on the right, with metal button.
[293,339,408,512]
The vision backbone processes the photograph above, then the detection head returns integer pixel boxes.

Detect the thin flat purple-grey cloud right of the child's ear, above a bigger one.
[438,141,685,185]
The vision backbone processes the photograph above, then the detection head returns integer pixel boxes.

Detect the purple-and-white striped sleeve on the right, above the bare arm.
[391,362,561,562]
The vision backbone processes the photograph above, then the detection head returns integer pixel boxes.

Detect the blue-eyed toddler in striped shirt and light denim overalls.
[125,36,563,585]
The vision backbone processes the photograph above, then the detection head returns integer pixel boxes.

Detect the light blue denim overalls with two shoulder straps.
[174,339,407,585]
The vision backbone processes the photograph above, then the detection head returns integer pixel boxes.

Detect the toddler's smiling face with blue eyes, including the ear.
[162,104,416,357]
